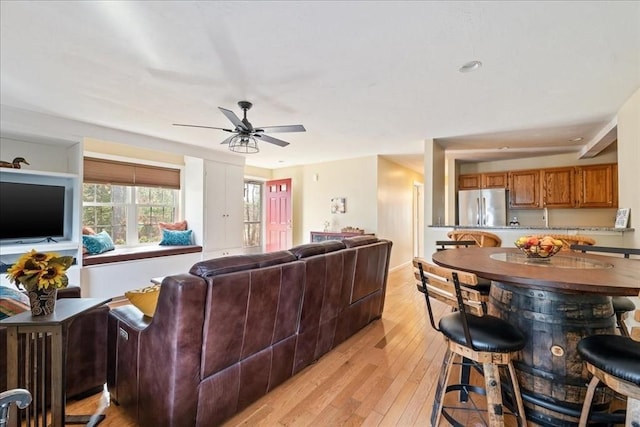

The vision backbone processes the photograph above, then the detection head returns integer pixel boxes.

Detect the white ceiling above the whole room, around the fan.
[0,1,640,174]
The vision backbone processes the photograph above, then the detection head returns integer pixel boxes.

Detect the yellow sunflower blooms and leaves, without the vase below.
[7,249,73,291]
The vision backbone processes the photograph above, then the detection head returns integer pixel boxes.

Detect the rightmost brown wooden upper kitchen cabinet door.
[577,163,618,208]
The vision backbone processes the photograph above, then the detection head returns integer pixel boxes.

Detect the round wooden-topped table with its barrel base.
[432,247,640,426]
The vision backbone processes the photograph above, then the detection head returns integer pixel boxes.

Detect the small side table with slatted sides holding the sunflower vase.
[0,298,111,427]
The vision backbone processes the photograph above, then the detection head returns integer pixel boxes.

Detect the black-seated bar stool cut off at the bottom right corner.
[578,335,640,427]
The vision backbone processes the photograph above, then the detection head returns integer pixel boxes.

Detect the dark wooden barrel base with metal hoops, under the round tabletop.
[489,282,616,426]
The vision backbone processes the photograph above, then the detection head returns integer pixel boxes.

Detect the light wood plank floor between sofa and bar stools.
[67,266,500,427]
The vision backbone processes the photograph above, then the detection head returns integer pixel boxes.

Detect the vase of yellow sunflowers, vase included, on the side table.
[7,249,73,316]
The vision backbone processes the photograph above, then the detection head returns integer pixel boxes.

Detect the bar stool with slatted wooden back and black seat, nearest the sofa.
[413,258,526,426]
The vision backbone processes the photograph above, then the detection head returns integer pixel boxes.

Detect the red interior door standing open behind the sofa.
[265,178,293,252]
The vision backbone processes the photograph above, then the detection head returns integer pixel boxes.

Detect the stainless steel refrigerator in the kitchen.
[458,188,507,227]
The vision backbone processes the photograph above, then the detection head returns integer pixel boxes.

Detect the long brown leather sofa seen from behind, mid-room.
[107,236,392,426]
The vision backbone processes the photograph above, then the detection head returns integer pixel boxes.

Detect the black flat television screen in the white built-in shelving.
[0,182,65,243]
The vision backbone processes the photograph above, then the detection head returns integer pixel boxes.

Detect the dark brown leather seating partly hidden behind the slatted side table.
[0,286,109,400]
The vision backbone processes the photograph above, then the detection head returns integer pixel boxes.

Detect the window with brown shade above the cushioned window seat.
[82,158,180,246]
